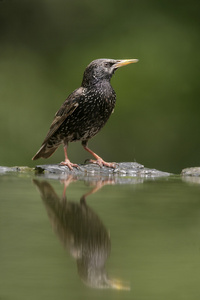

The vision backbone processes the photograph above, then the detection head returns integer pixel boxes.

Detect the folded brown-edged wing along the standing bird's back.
[43,88,83,144]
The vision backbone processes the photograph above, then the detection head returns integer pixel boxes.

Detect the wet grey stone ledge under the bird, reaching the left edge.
[0,162,171,184]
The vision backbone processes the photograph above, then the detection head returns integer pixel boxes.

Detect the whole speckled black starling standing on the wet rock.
[32,58,138,170]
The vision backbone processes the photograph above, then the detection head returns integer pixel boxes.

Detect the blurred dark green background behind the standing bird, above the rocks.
[0,0,200,173]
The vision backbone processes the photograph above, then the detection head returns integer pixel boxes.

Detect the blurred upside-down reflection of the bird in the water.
[33,177,130,290]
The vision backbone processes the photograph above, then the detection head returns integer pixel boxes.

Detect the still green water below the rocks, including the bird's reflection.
[0,174,200,300]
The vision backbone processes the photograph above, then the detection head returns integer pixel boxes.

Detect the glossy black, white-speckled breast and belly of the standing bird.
[57,86,116,142]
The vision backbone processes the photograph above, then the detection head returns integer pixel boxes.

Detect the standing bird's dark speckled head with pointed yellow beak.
[82,58,138,87]
